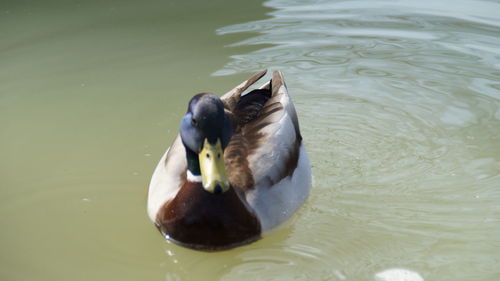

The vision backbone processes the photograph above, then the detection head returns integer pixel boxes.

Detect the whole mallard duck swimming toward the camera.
[147,70,311,251]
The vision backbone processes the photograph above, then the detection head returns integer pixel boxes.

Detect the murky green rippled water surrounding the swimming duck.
[0,0,500,281]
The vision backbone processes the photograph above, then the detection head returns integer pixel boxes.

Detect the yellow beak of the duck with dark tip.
[198,139,229,193]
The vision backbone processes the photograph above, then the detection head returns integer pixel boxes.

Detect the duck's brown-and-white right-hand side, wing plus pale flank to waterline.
[224,71,311,232]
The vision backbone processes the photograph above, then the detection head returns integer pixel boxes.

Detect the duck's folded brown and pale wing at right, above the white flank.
[225,71,302,189]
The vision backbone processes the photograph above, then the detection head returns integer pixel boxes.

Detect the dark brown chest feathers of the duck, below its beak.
[156,181,261,251]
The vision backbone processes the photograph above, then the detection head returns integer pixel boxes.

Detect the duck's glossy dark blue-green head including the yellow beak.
[180,94,232,194]
